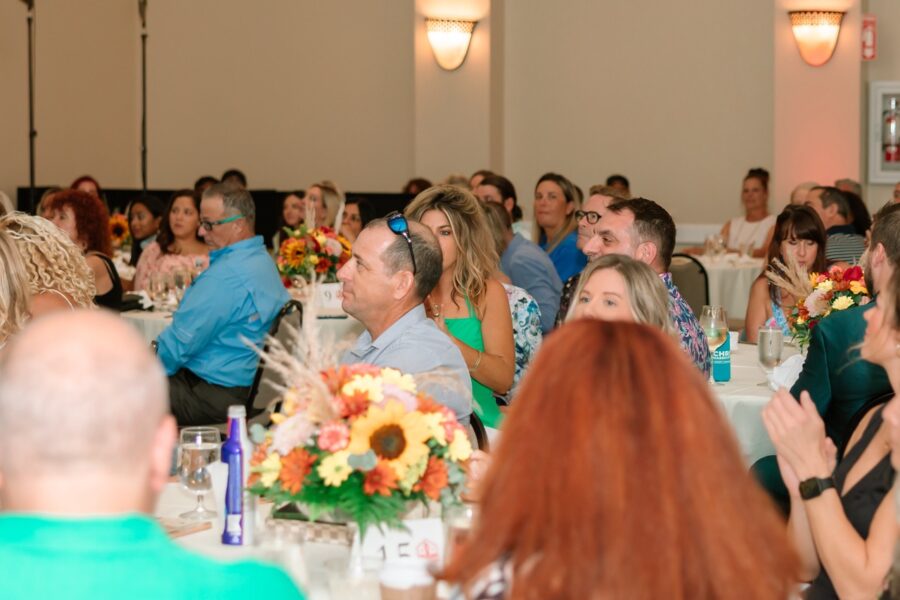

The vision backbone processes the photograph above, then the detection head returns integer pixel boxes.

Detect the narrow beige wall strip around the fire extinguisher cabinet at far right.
[862,0,900,210]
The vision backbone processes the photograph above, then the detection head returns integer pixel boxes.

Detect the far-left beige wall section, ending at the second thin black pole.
[0,0,140,206]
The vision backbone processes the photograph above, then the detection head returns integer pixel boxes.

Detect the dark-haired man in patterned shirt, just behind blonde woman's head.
[584,198,710,376]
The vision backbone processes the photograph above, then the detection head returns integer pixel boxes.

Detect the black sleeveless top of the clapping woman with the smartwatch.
[806,406,894,600]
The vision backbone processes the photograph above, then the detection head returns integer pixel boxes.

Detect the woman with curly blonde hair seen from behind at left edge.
[0,213,96,317]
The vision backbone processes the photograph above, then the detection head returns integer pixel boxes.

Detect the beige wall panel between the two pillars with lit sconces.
[504,0,773,222]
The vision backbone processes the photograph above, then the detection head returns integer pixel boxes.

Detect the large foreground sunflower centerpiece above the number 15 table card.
[249,364,472,535]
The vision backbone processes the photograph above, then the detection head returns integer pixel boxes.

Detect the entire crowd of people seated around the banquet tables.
[0,169,900,600]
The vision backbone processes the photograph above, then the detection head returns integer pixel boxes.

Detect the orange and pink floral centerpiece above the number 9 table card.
[276,225,350,287]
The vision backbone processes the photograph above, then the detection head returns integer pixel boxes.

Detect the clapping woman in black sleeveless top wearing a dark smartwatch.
[763,270,900,600]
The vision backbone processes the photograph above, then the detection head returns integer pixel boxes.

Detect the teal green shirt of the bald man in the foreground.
[0,514,303,600]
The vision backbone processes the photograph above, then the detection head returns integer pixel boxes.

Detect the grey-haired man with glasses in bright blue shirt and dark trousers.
[157,184,289,427]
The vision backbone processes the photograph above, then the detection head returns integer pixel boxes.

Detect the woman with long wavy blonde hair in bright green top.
[405,185,516,428]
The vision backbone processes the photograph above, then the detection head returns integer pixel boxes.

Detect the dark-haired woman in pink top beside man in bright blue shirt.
[134,189,209,290]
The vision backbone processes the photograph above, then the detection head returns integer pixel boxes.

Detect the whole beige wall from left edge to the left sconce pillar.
[0,0,414,203]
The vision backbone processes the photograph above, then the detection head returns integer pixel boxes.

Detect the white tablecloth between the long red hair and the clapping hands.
[710,344,797,467]
